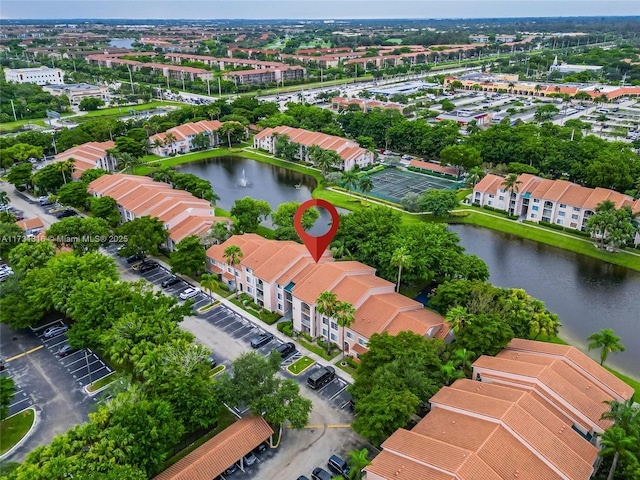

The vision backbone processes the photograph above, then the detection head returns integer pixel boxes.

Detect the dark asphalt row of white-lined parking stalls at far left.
[37,321,113,387]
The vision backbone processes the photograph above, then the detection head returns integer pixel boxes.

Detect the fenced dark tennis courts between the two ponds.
[360,168,460,204]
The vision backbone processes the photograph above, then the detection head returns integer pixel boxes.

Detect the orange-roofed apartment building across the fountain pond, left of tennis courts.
[253,125,374,171]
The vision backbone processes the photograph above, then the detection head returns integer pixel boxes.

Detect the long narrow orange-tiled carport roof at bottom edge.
[154,415,273,480]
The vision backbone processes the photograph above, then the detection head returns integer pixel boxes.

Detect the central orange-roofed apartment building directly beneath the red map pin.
[207,234,452,358]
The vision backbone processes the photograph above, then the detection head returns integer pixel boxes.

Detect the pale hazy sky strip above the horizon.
[0,0,640,20]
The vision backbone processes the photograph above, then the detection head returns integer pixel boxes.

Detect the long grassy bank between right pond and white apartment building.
[451,210,640,271]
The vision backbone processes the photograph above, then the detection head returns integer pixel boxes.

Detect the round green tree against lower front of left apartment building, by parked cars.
[116,216,169,257]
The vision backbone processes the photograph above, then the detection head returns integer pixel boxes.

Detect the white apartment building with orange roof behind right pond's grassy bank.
[472,173,640,244]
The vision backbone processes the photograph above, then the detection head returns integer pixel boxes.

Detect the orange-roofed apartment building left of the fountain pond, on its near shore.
[88,174,231,251]
